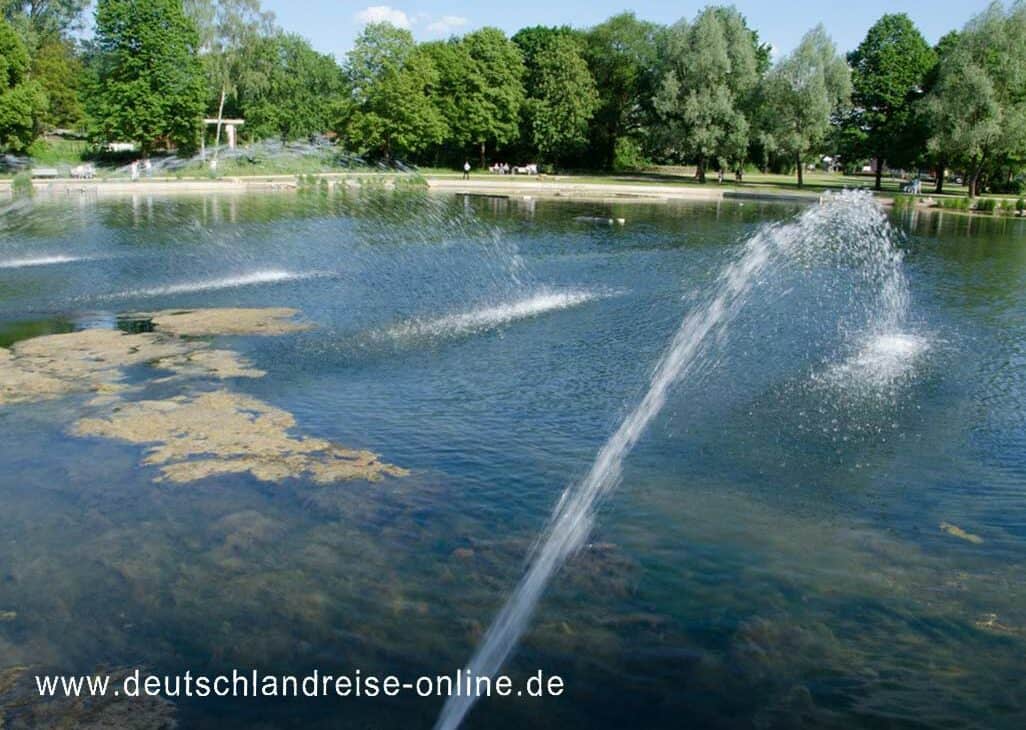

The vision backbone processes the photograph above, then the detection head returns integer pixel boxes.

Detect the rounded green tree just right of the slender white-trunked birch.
[238,33,345,141]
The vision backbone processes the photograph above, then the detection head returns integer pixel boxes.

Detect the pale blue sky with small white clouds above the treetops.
[264,0,989,60]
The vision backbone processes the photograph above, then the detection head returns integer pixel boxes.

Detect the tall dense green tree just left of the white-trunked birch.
[90,0,204,155]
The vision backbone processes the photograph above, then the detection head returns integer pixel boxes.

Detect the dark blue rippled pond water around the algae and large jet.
[0,193,1026,728]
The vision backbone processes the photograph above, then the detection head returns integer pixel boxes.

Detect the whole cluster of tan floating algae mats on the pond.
[0,308,407,484]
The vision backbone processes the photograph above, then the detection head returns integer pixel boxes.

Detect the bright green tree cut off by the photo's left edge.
[0,19,46,152]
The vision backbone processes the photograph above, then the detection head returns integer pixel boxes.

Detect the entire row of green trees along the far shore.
[0,0,1026,195]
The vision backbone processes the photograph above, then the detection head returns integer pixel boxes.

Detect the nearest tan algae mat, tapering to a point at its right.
[73,391,407,484]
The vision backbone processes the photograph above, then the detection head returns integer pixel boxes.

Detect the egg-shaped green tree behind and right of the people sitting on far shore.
[527,34,598,159]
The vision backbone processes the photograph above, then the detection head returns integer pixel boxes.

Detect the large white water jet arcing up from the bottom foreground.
[435,192,913,730]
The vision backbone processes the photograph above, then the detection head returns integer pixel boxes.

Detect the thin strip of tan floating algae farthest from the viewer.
[139,307,311,337]
